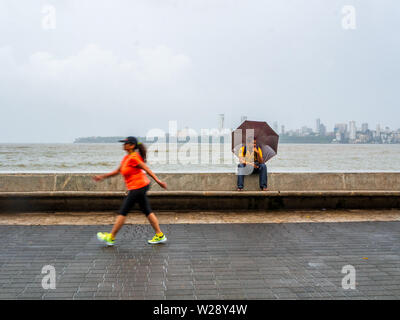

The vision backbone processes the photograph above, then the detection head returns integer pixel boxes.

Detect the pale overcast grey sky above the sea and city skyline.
[0,0,400,142]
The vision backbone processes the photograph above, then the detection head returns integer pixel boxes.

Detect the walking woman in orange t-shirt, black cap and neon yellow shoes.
[93,137,167,246]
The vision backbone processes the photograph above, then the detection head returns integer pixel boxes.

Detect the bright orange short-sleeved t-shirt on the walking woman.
[119,152,150,190]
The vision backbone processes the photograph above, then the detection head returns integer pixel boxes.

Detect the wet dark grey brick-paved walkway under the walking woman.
[0,221,400,300]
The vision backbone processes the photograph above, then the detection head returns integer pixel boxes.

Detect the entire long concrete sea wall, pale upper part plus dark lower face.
[0,173,400,213]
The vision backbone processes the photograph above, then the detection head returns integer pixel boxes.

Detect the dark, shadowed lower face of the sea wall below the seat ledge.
[0,190,400,212]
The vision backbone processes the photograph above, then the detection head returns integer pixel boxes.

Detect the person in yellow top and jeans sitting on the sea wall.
[237,138,268,191]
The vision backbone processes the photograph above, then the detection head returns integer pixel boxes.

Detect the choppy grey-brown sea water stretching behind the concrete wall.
[0,143,400,173]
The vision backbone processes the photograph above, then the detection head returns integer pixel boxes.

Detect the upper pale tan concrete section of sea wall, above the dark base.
[0,172,400,192]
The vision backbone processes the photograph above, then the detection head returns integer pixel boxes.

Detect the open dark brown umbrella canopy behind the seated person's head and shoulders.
[232,120,279,162]
